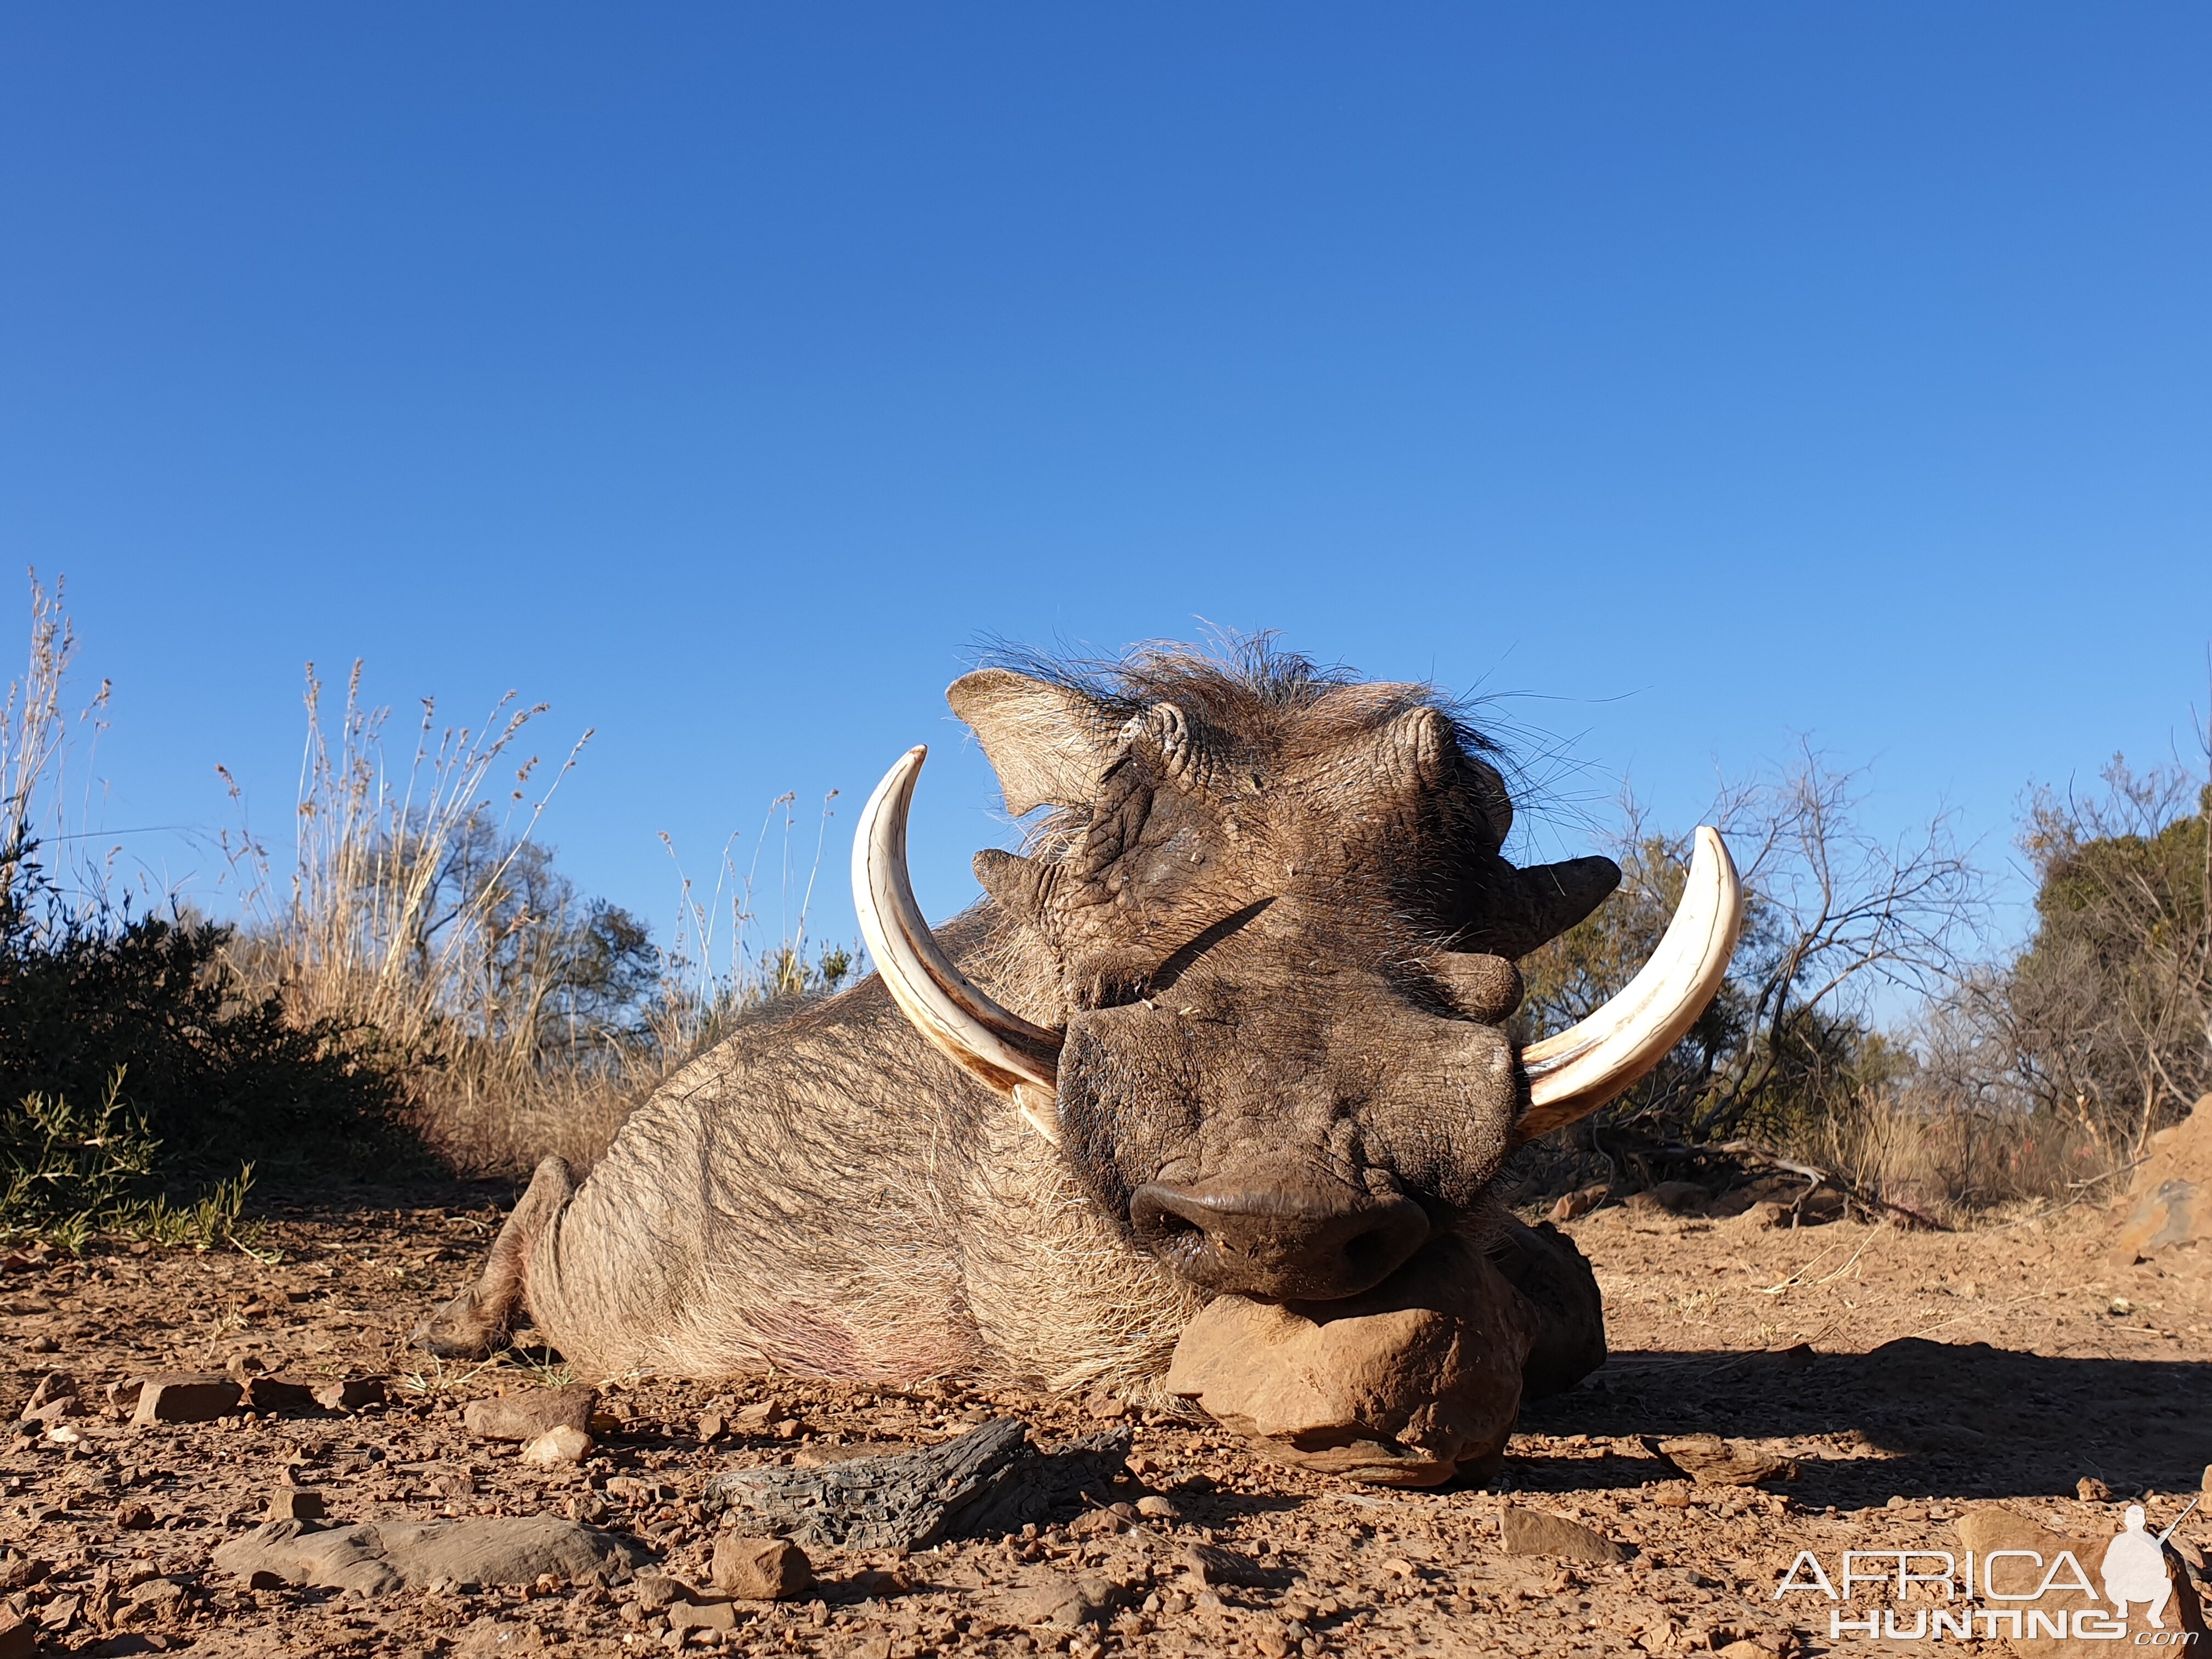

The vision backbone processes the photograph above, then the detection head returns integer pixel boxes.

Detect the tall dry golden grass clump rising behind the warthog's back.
[225,664,854,1175]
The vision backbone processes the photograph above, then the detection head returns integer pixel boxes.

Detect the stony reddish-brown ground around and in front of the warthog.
[0,1188,2212,1659]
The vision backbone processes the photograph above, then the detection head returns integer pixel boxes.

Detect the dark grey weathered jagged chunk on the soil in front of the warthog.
[701,1418,1029,1550]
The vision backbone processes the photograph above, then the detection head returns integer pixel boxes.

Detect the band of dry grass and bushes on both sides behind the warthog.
[0,582,2212,1232]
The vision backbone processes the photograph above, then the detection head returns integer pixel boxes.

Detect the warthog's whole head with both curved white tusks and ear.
[854,650,1736,1301]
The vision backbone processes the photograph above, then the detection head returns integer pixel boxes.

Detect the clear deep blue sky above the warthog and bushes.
[0,2,2212,960]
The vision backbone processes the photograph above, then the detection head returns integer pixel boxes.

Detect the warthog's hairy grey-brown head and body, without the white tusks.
[418,650,1619,1389]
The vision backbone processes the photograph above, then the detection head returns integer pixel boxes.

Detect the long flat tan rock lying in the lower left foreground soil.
[215,1515,641,1595]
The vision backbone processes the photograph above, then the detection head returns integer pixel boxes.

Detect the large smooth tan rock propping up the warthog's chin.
[1166,1237,1537,1487]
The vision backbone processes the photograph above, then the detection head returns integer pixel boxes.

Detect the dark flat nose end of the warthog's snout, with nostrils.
[1128,1181,1429,1301]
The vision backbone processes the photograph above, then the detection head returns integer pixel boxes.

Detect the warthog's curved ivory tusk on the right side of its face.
[1513,825,1743,1142]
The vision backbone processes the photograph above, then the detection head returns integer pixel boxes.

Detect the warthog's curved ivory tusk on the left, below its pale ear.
[851,746,1059,1144]
